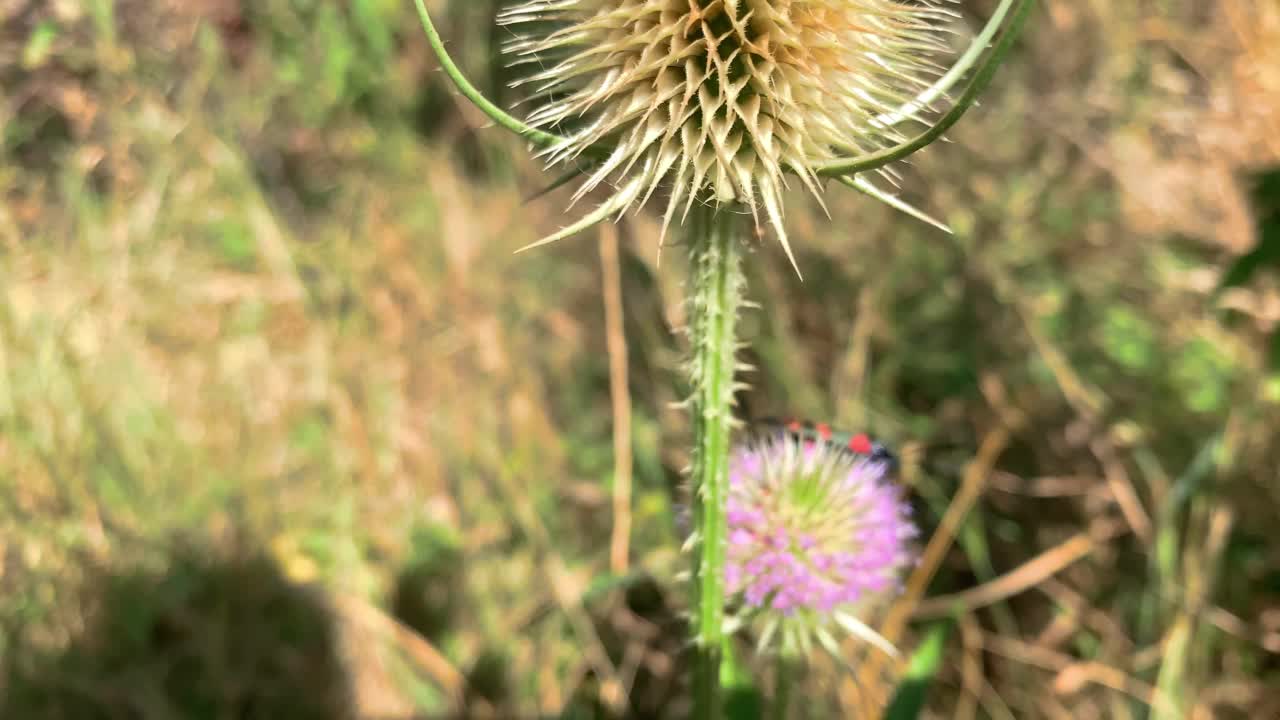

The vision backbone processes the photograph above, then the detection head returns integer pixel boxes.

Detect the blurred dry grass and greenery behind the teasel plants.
[0,0,1280,719]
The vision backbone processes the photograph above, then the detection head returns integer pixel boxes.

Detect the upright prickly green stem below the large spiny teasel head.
[689,208,745,719]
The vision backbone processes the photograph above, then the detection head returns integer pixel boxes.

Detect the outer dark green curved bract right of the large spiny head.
[814,0,1036,177]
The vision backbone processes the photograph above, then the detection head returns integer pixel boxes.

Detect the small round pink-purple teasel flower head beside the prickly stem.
[724,425,916,656]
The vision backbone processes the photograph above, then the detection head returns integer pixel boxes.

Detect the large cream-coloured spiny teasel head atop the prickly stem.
[500,0,951,263]
